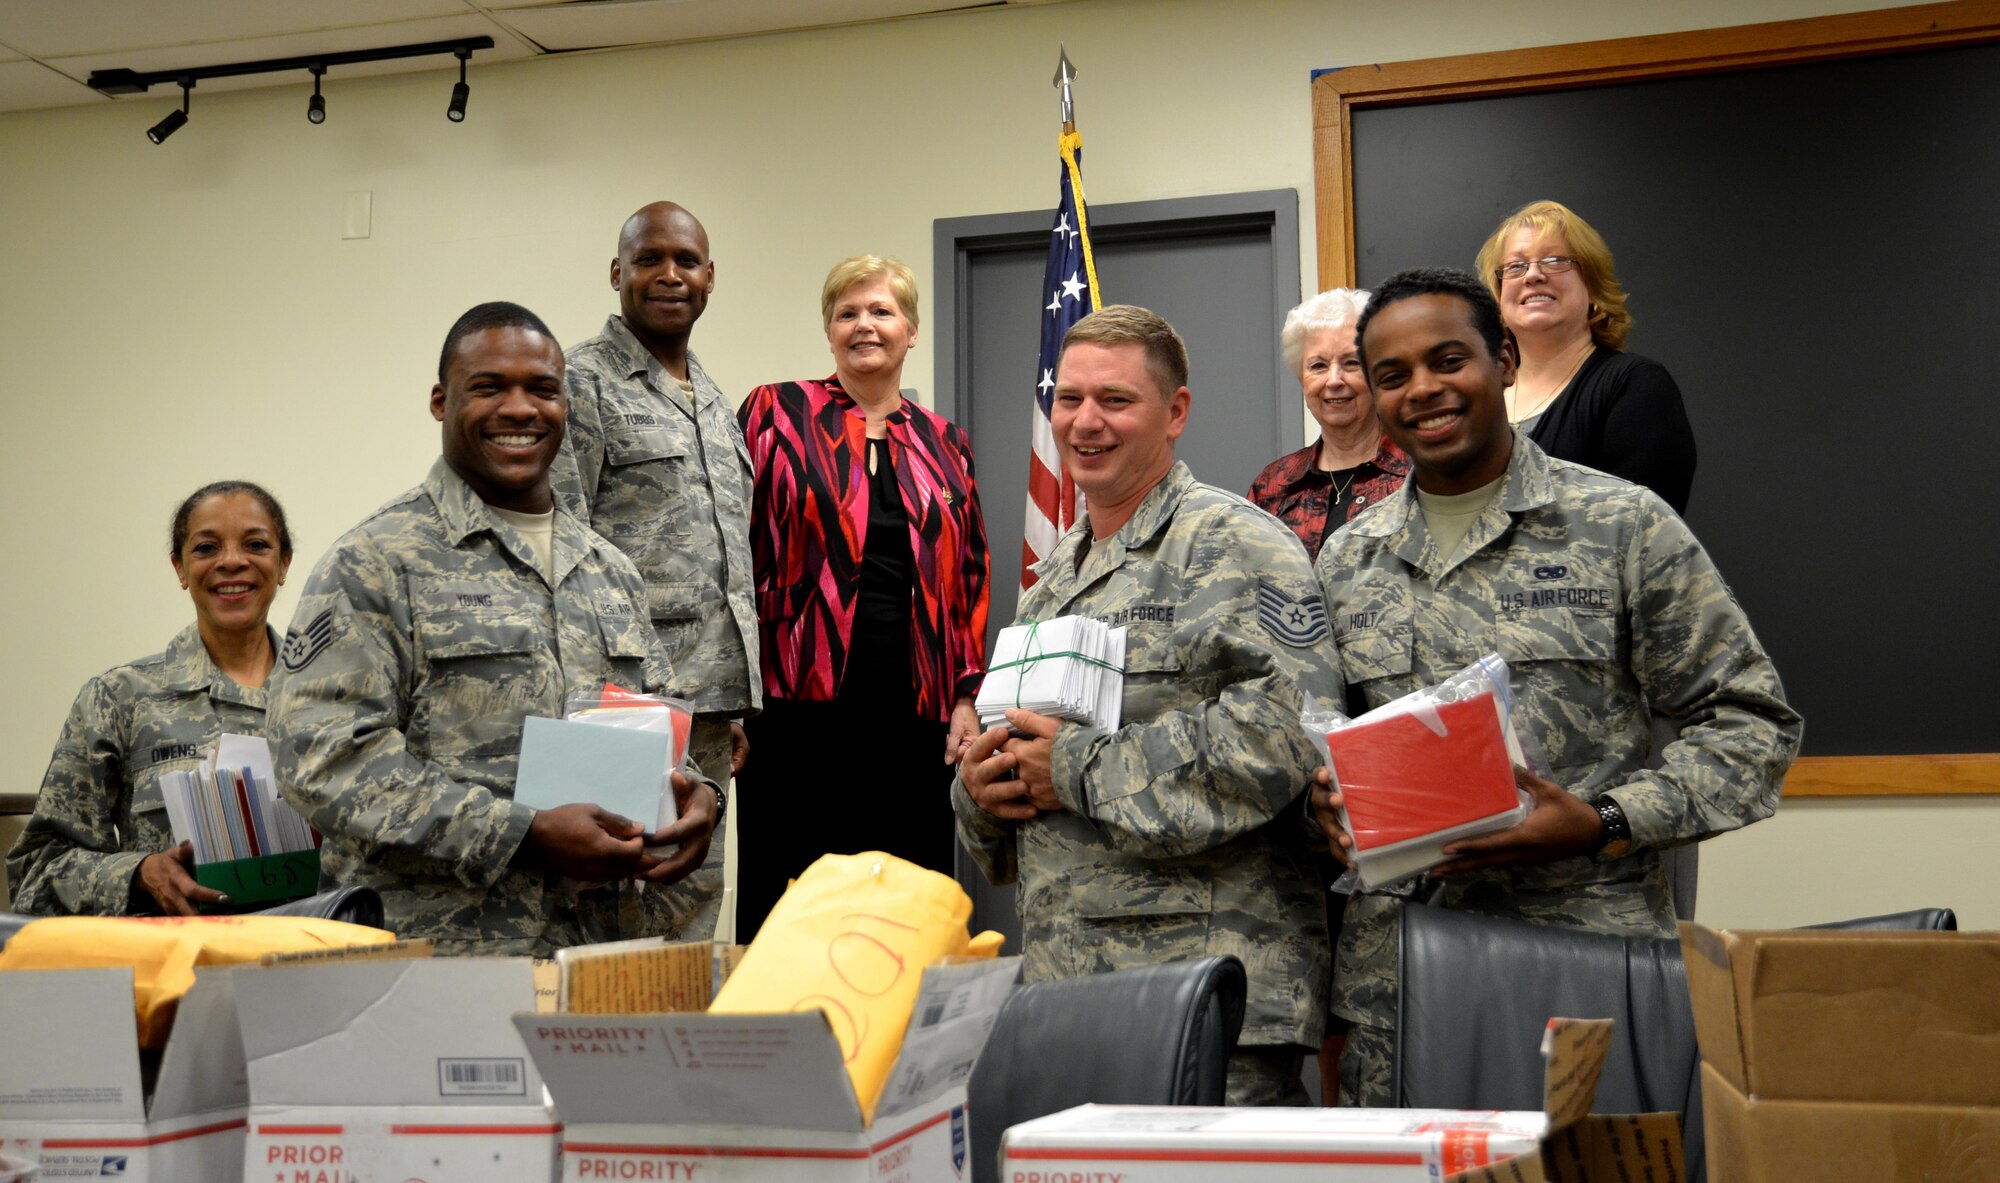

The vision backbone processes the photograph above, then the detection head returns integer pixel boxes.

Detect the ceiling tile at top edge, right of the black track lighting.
[490,0,990,50]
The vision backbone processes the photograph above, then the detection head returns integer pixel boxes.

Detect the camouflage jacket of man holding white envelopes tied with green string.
[952,462,1340,1047]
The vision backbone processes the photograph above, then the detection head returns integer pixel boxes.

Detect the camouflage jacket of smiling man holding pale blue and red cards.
[270,460,708,955]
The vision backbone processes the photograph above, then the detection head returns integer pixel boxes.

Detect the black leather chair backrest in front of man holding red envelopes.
[1394,903,1706,1179]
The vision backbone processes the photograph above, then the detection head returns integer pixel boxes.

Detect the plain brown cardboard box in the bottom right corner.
[1680,923,2000,1183]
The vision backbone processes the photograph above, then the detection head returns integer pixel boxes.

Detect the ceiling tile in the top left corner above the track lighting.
[0,0,474,58]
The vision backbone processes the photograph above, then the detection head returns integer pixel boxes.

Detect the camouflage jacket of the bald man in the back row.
[550,316,762,717]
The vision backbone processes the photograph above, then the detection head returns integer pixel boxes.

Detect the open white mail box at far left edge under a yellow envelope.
[0,967,250,1183]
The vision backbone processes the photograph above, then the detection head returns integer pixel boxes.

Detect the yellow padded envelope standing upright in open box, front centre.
[708,851,1000,1121]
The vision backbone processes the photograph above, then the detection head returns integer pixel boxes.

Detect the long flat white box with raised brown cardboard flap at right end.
[1000,1019,1682,1183]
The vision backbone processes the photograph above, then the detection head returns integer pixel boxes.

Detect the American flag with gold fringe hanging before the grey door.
[1020,124,1100,592]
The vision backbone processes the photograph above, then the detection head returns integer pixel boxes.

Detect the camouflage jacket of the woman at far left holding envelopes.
[6,623,278,915]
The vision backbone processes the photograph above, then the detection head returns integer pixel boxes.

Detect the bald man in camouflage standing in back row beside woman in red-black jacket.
[550,202,762,937]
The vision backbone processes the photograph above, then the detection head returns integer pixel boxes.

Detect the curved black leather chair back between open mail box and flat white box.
[966,957,1248,1183]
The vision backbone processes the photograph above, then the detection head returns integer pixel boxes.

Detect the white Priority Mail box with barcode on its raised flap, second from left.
[238,957,560,1183]
